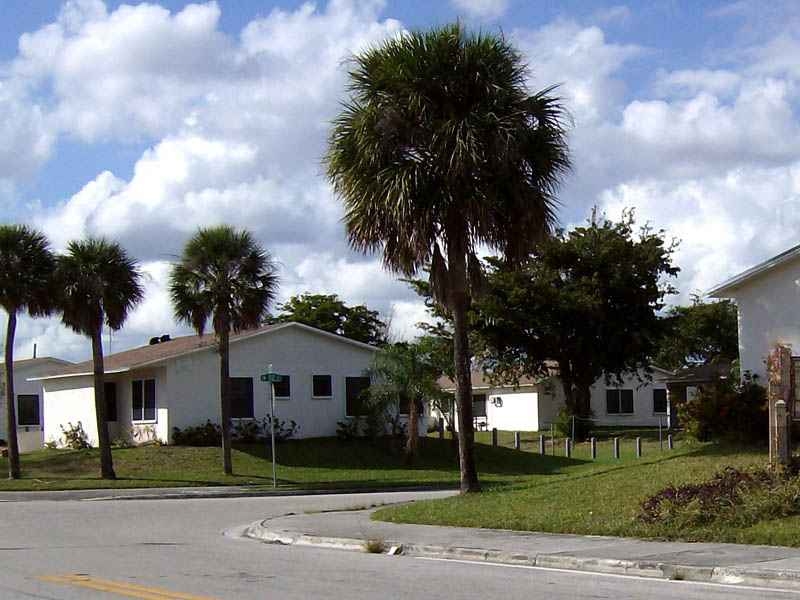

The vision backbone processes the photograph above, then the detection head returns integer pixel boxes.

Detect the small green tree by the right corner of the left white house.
[372,342,442,463]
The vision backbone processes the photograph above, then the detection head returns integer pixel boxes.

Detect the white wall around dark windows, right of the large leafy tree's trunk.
[591,373,667,427]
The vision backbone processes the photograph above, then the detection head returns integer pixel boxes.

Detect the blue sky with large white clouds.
[0,0,800,360]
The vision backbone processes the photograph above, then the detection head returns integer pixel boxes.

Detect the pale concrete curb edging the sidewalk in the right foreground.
[242,519,800,590]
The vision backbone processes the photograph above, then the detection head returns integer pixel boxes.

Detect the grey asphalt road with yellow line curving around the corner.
[0,492,800,600]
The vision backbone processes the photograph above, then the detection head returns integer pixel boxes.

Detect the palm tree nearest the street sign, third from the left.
[170,225,278,475]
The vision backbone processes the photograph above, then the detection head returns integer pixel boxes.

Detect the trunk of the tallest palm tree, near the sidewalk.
[447,239,481,494]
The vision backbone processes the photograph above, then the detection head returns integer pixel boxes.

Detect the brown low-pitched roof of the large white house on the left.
[30,322,377,381]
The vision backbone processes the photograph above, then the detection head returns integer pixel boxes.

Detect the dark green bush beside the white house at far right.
[676,373,769,442]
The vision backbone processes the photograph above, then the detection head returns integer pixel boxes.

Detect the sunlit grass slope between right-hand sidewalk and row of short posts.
[375,434,800,546]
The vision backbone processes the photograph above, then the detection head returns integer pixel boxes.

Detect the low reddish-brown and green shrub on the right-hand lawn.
[639,467,800,530]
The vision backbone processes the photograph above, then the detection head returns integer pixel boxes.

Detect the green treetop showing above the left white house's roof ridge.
[272,294,386,345]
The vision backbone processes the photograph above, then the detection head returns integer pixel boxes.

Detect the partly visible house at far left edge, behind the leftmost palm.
[0,356,72,452]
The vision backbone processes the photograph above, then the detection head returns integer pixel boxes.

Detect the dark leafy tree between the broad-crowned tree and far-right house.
[654,296,739,369]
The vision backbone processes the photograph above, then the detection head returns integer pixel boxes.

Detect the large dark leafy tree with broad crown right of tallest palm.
[478,213,679,416]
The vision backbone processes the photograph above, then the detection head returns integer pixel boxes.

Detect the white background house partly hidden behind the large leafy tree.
[434,367,672,431]
